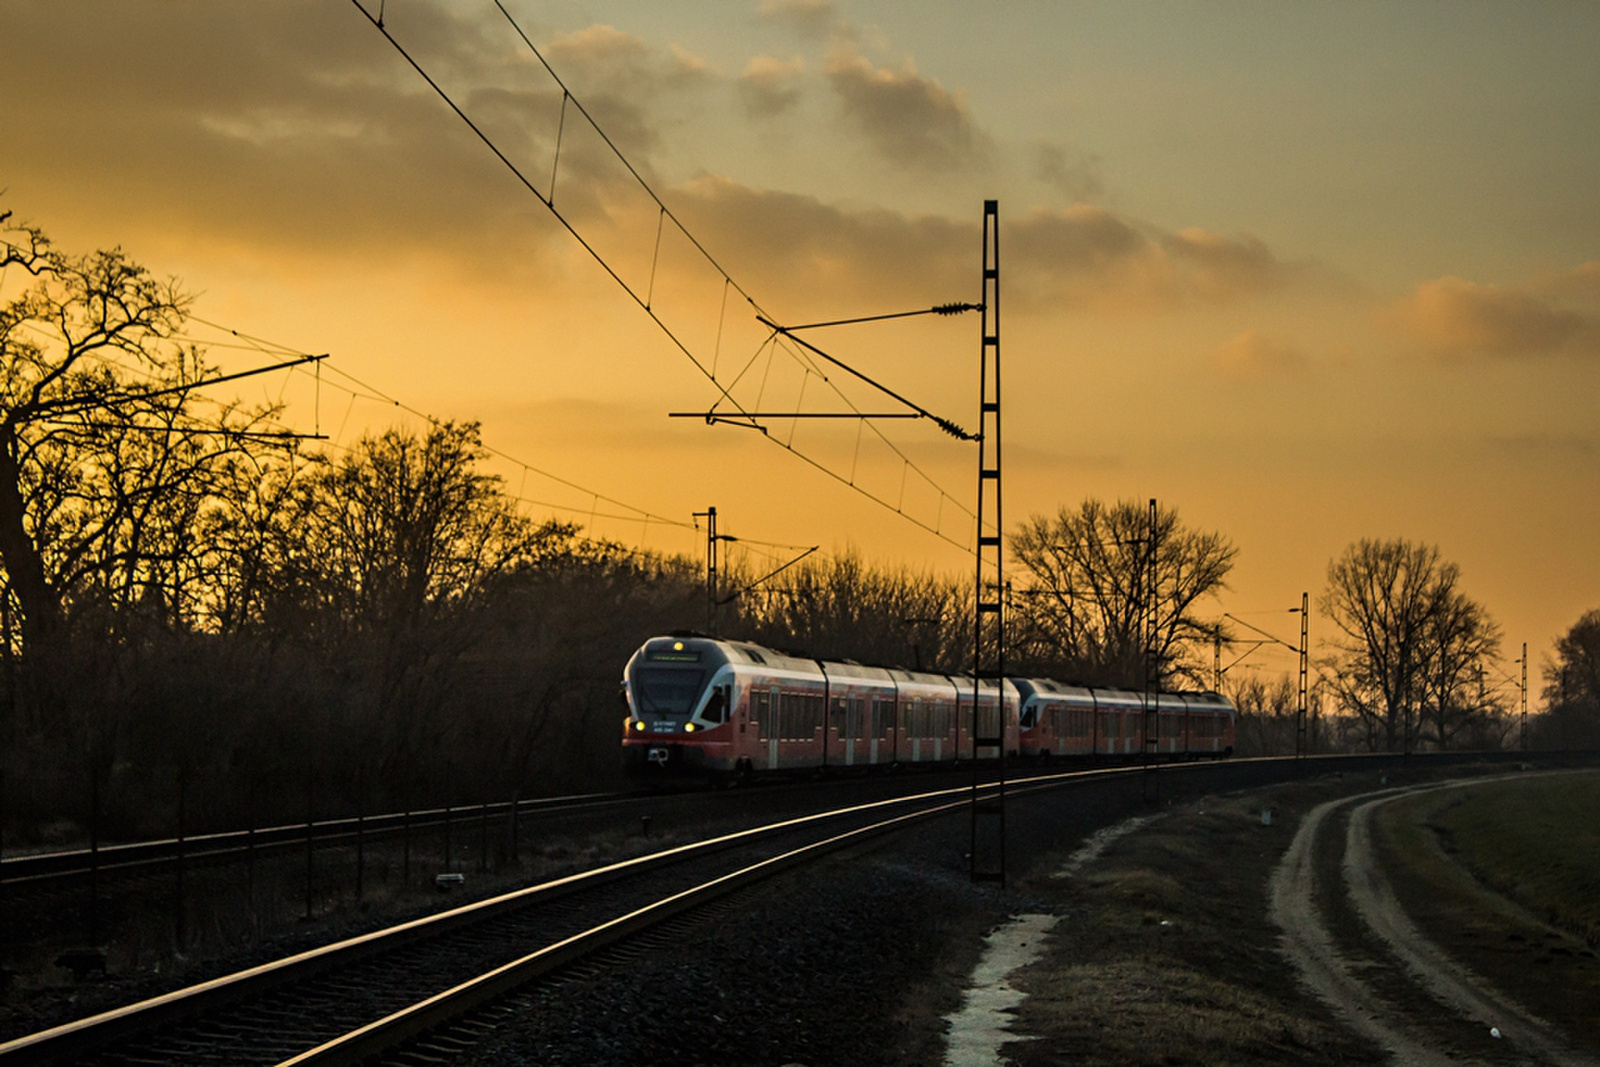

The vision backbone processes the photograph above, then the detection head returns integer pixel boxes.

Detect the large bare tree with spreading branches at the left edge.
[0,211,283,651]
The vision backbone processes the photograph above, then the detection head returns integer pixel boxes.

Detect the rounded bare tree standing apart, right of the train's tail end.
[1320,539,1499,752]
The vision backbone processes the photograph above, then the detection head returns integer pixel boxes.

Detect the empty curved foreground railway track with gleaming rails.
[0,787,970,1064]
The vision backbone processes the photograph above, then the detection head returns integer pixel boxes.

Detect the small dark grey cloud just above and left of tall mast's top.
[826,42,987,171]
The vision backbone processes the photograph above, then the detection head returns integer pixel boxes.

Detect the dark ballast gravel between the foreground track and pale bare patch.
[461,819,1037,1067]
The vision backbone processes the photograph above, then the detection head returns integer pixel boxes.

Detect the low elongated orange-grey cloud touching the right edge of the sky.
[1387,275,1600,358]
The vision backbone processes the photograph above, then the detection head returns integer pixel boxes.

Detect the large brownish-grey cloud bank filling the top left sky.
[0,0,710,277]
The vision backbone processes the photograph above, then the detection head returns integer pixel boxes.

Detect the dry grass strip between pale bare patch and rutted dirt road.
[1006,787,1366,1067]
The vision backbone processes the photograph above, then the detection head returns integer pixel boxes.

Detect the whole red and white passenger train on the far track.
[622,637,1234,779]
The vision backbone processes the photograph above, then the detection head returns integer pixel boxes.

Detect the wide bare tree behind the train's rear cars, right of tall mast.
[1010,499,1237,688]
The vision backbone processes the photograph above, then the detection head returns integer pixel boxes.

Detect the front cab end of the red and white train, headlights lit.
[622,637,738,777]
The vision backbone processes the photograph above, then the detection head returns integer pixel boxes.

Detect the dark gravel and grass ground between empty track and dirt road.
[9,763,1587,1067]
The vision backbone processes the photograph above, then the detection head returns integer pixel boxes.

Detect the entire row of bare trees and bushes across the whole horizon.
[0,213,1600,848]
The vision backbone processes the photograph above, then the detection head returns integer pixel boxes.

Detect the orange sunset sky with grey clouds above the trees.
[0,0,1600,691]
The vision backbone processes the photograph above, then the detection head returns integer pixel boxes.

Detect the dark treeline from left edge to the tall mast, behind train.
[0,207,971,846]
